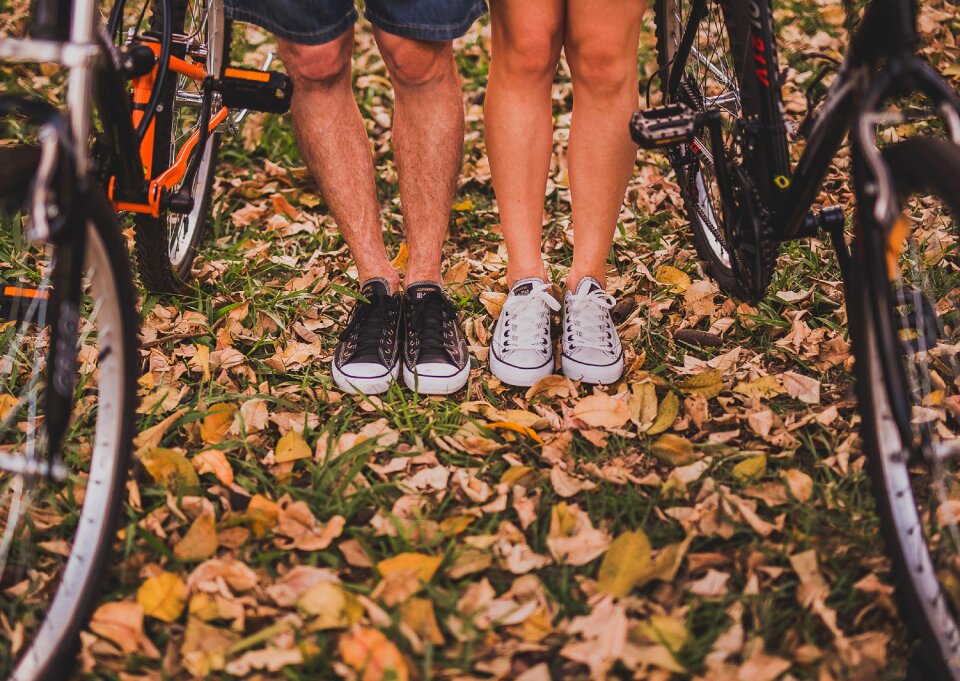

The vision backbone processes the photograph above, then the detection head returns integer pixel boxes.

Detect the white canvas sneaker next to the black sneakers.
[490,277,560,387]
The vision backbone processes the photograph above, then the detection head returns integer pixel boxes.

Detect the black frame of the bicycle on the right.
[665,0,960,242]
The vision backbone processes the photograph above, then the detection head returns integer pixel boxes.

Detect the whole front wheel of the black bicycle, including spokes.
[847,137,960,679]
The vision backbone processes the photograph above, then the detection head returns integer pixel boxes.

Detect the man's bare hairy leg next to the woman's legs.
[374,27,464,284]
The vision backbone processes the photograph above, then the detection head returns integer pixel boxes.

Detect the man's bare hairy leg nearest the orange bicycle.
[277,28,400,290]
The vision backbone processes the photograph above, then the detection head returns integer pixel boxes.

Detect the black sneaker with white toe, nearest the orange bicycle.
[333,279,403,395]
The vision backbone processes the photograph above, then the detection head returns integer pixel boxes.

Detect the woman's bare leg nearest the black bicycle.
[564,0,646,290]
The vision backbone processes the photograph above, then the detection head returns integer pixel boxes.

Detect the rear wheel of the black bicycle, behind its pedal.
[654,0,760,298]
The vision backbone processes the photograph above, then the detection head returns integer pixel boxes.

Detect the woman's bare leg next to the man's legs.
[484,0,568,285]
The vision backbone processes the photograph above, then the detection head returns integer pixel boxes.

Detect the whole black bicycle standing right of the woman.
[630,0,960,679]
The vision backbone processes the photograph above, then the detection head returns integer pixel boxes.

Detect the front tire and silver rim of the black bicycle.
[847,137,960,679]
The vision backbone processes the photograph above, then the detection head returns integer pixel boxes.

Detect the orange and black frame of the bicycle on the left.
[0,0,234,217]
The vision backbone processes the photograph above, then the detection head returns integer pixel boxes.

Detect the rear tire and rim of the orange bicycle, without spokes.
[135,0,230,293]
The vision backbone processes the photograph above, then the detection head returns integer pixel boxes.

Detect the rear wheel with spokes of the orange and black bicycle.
[136,0,230,293]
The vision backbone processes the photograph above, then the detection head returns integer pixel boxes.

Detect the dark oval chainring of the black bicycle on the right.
[726,164,780,305]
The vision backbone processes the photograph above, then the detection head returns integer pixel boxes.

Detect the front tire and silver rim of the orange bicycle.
[0,182,139,681]
